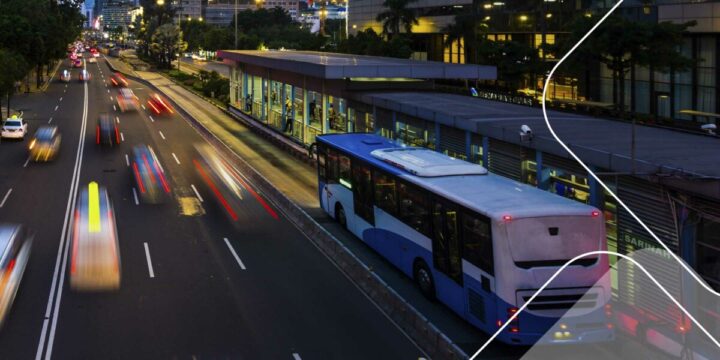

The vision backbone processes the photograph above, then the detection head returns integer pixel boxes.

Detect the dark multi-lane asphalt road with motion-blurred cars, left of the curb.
[0,56,424,359]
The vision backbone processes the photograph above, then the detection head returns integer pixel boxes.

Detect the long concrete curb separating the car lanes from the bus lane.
[106,60,469,360]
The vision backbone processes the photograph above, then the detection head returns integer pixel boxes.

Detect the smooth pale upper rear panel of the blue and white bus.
[507,216,604,269]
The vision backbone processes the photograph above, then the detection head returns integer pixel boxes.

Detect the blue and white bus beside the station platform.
[317,134,614,345]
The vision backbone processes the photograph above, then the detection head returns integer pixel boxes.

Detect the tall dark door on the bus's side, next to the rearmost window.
[431,198,465,314]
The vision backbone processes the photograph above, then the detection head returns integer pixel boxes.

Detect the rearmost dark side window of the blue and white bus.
[462,210,495,275]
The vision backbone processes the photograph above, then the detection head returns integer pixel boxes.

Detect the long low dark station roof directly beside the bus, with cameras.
[355,92,720,198]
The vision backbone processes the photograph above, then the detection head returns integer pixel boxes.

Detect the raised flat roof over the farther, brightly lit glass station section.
[218,50,497,80]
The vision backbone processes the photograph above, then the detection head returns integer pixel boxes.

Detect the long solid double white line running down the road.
[35,60,88,360]
